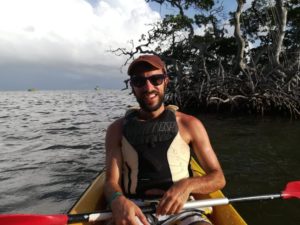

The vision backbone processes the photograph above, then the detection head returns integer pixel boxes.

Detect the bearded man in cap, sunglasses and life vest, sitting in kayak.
[104,55,225,225]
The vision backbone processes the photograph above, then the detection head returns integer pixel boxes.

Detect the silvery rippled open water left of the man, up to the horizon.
[0,90,134,213]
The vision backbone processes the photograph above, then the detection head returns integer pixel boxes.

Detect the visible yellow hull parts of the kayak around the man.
[68,158,247,225]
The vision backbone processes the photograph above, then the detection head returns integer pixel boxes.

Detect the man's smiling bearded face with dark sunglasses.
[130,69,168,112]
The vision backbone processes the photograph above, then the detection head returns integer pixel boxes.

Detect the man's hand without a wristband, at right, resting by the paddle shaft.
[156,179,190,215]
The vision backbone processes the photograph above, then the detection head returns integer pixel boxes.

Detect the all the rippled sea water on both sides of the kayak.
[0,90,300,225]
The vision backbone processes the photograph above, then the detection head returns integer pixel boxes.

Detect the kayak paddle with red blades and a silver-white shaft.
[0,181,300,225]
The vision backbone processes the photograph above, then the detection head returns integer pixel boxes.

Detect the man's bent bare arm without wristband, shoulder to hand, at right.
[157,113,225,214]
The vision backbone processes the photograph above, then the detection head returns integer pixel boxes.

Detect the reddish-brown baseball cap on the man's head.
[127,55,167,76]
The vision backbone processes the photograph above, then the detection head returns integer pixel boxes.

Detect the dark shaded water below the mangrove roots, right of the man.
[199,115,300,225]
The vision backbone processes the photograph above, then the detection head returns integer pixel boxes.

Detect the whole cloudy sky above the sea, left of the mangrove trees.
[0,0,244,91]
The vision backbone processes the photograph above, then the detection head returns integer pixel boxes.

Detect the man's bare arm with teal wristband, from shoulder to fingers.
[104,119,148,225]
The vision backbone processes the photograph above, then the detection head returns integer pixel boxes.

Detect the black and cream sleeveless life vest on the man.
[122,106,191,197]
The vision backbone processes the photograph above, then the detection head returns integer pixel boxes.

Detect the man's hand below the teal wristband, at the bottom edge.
[111,196,149,225]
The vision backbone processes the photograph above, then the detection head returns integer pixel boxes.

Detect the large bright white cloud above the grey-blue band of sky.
[0,0,160,89]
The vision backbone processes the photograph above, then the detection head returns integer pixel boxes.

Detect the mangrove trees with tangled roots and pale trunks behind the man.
[113,0,300,118]
